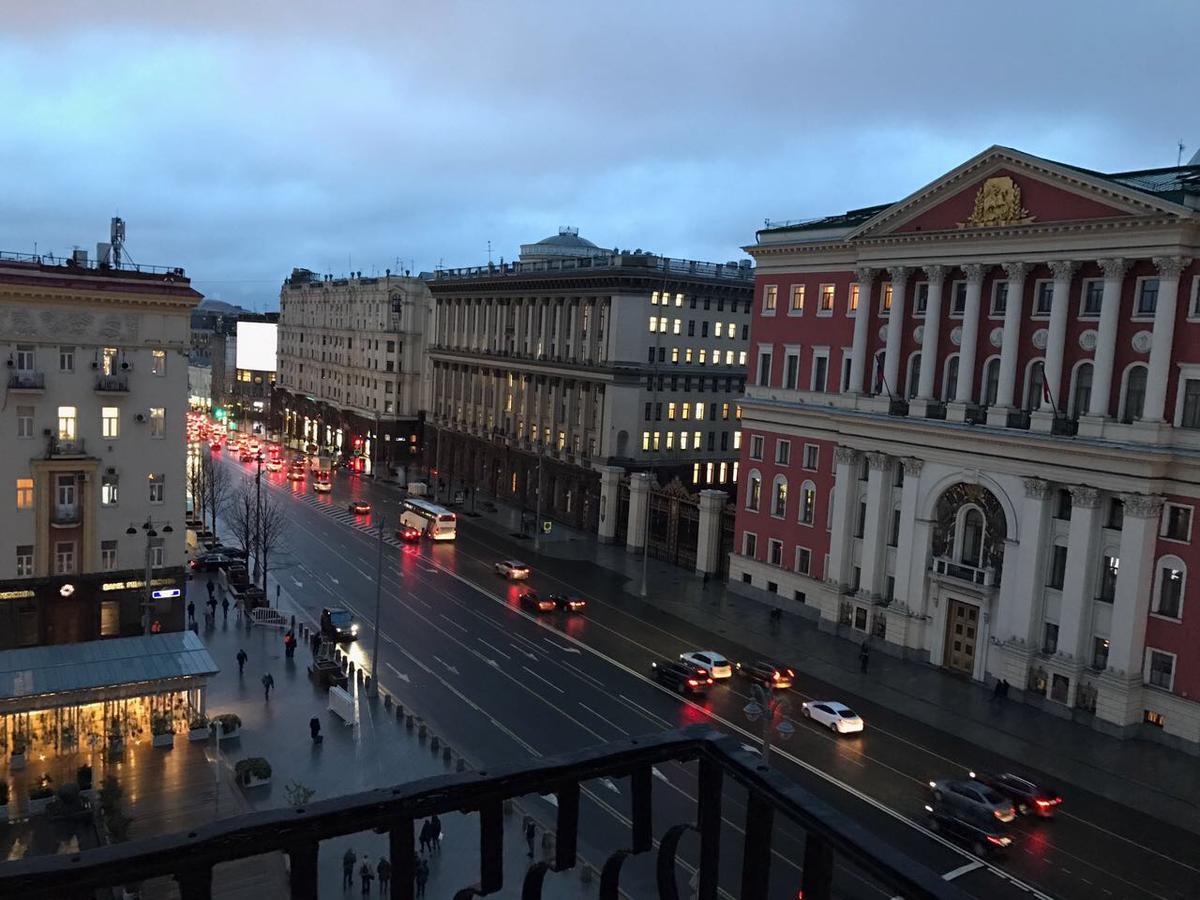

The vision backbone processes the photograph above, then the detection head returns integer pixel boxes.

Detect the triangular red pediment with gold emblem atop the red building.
[848,146,1189,240]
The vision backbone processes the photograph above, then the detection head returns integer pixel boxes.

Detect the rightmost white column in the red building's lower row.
[1109,494,1163,677]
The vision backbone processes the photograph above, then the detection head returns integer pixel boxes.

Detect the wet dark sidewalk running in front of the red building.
[444,487,1200,833]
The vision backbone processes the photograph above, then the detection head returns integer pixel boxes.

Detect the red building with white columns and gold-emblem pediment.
[730,146,1200,748]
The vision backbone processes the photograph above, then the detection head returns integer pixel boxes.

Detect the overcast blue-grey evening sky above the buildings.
[0,0,1200,308]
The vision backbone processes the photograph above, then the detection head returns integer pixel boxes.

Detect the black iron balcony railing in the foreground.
[0,726,966,900]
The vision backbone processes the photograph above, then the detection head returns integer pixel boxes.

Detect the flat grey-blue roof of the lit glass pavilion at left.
[0,631,220,709]
